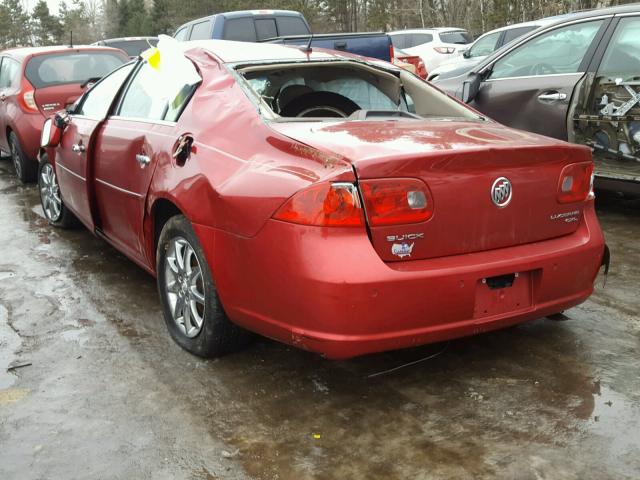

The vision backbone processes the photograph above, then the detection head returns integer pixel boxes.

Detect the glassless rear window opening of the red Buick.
[240,61,477,121]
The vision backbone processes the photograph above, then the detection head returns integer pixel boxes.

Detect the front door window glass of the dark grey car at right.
[489,20,602,79]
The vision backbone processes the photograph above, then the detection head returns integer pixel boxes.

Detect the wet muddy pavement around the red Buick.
[0,160,640,480]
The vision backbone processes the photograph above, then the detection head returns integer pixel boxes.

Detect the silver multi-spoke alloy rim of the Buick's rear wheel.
[164,237,205,338]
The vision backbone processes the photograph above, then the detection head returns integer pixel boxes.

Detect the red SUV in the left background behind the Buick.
[0,47,129,182]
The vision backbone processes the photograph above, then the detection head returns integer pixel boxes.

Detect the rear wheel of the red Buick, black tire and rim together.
[156,215,250,358]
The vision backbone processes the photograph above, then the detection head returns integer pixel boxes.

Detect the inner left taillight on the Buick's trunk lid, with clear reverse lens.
[360,178,433,227]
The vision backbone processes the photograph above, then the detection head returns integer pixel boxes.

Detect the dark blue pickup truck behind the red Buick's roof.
[173,10,393,62]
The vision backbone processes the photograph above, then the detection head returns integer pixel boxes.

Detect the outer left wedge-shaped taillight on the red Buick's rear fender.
[274,183,364,227]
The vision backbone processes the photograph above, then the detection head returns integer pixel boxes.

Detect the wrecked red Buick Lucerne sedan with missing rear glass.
[39,40,608,359]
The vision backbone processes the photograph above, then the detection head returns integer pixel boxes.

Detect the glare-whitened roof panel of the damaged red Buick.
[185,40,355,63]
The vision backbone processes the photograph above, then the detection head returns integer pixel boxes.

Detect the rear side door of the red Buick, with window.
[93,63,198,263]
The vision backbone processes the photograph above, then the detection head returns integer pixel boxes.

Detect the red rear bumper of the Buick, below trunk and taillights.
[196,204,604,358]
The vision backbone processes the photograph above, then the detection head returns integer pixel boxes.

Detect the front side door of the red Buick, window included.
[55,64,133,230]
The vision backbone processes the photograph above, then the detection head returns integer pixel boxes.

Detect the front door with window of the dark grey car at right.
[471,19,608,140]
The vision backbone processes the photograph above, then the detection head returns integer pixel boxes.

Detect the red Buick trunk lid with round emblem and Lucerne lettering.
[274,121,590,261]
